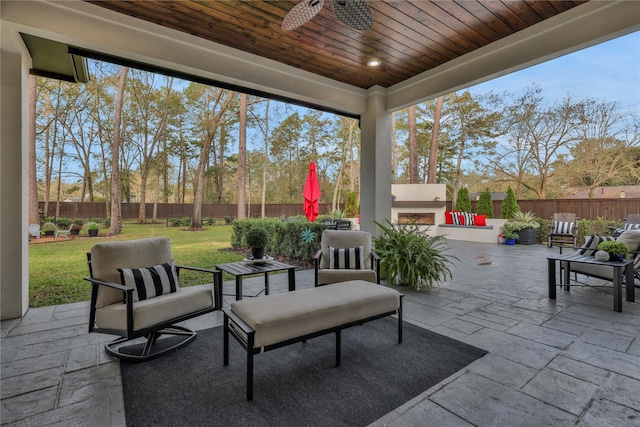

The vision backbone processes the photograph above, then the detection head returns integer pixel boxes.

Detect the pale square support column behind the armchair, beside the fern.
[360,86,391,236]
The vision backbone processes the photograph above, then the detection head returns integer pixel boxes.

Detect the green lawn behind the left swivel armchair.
[29,223,245,307]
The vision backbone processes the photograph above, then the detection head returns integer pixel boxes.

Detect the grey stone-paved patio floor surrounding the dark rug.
[0,240,640,426]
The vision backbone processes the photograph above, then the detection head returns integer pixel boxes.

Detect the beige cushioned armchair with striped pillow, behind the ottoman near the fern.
[314,230,380,286]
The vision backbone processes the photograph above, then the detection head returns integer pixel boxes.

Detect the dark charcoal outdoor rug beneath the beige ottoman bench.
[120,318,486,427]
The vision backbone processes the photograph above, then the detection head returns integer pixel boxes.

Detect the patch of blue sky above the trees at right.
[469,32,640,113]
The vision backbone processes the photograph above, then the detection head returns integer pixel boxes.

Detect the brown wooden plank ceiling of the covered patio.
[87,0,587,88]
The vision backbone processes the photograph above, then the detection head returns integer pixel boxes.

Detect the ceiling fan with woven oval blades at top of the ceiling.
[282,0,373,31]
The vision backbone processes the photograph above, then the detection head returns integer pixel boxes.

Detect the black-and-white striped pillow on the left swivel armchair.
[118,261,180,301]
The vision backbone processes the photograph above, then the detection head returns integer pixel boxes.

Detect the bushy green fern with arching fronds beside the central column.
[375,220,458,290]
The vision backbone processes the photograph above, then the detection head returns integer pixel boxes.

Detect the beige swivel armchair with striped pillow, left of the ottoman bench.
[85,238,222,362]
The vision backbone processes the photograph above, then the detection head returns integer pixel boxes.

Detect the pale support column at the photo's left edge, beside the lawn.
[0,47,29,320]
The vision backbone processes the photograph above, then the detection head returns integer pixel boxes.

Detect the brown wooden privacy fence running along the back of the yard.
[40,199,640,221]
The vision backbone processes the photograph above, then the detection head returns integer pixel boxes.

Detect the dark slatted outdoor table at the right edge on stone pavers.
[547,254,635,311]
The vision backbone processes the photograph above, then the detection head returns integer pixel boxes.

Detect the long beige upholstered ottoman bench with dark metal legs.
[222,280,403,400]
